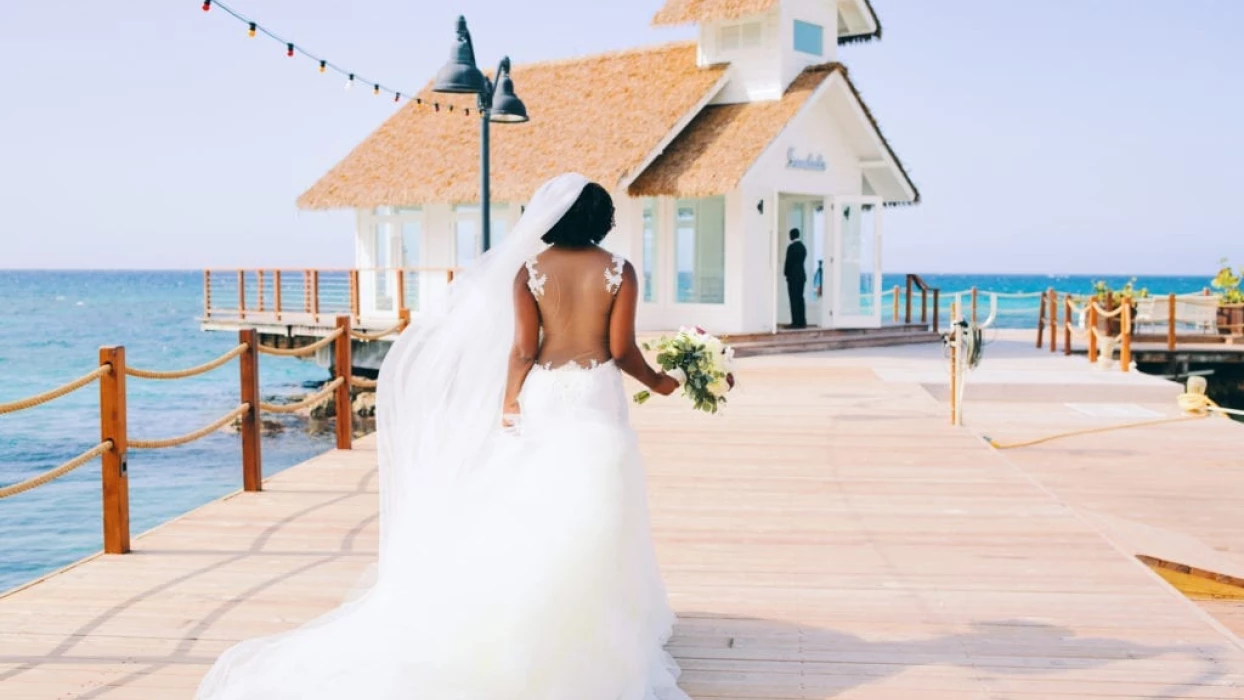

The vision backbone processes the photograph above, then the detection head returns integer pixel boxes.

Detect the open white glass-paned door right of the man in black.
[825,196,882,328]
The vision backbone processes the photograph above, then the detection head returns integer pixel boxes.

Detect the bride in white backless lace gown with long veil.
[197,174,689,700]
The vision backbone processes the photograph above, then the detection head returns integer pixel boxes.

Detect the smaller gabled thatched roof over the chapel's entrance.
[628,63,919,203]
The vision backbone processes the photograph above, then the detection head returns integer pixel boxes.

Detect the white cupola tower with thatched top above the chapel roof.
[658,0,881,104]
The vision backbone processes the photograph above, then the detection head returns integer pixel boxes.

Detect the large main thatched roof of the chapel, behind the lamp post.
[299,42,725,209]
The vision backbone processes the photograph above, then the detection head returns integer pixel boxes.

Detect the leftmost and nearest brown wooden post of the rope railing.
[100,347,129,555]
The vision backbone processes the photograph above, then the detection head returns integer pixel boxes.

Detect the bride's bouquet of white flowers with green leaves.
[634,328,734,413]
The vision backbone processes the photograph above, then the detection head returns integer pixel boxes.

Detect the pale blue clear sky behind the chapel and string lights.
[0,0,1244,274]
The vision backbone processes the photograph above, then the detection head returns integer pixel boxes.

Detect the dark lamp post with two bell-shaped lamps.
[432,17,527,251]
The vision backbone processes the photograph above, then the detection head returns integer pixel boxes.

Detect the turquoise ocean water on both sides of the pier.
[0,270,1207,591]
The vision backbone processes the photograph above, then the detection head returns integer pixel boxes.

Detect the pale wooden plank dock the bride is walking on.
[0,338,1244,700]
